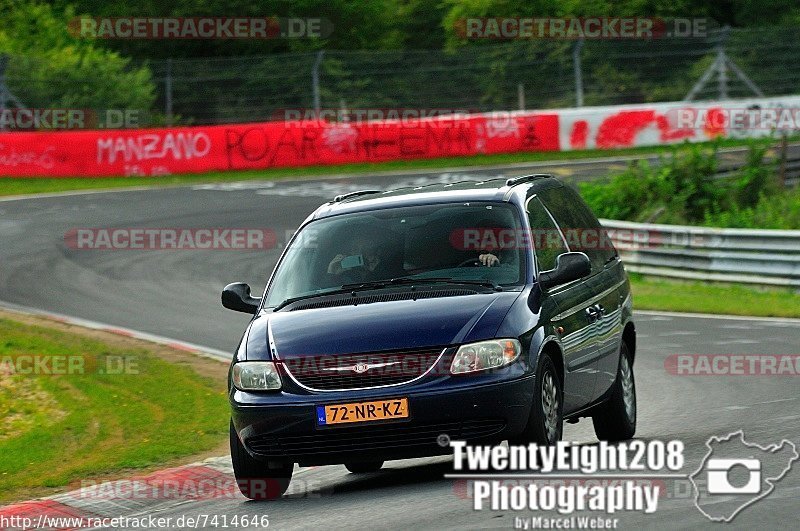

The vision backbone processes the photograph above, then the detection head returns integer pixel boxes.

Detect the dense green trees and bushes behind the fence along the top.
[0,0,800,123]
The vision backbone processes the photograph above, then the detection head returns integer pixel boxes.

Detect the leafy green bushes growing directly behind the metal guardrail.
[580,140,800,229]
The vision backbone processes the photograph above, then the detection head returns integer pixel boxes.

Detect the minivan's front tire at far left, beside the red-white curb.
[230,421,294,500]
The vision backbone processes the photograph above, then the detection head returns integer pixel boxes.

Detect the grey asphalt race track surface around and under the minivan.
[0,162,800,529]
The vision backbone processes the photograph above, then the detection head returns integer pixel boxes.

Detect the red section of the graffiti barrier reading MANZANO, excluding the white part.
[0,113,560,177]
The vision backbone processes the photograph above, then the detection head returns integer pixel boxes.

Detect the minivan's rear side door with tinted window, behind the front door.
[542,186,625,400]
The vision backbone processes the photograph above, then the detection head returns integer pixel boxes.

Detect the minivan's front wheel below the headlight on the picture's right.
[509,352,564,446]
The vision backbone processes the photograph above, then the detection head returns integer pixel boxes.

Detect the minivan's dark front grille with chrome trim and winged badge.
[282,348,443,391]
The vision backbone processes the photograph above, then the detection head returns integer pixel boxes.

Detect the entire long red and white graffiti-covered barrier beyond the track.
[0,96,800,177]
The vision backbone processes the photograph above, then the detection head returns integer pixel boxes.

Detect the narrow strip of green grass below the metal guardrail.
[631,275,800,317]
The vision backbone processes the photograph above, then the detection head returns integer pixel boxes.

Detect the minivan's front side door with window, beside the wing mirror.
[526,195,597,413]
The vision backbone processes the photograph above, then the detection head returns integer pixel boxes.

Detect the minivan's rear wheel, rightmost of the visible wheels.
[592,341,636,442]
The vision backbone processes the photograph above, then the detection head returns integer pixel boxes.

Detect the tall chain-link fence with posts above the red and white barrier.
[0,28,800,124]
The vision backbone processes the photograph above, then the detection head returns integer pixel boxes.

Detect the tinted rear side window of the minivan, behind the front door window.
[539,186,617,273]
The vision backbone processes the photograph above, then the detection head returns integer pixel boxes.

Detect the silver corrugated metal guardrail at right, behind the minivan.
[601,219,800,288]
